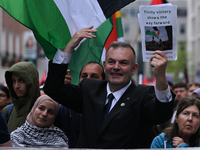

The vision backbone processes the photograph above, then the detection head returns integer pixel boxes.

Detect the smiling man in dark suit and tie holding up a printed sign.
[44,27,175,149]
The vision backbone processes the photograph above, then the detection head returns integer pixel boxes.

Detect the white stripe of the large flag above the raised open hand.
[54,0,106,36]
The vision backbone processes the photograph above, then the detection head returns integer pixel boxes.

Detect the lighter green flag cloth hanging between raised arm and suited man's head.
[69,19,112,84]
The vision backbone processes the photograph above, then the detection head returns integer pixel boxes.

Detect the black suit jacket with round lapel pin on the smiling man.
[44,62,175,149]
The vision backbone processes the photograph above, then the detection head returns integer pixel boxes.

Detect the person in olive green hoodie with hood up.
[3,62,40,133]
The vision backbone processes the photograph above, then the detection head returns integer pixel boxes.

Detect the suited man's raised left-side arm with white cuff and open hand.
[44,26,97,109]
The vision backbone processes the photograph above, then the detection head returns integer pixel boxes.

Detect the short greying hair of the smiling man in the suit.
[105,41,136,66]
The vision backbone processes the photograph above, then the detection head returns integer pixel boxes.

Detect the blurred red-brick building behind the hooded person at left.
[0,8,46,84]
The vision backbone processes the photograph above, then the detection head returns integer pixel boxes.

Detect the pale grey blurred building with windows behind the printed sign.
[121,0,187,82]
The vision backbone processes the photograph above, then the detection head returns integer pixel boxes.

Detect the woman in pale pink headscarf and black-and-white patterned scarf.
[11,95,68,148]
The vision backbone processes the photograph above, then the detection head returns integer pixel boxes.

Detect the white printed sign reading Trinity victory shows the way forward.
[138,4,177,62]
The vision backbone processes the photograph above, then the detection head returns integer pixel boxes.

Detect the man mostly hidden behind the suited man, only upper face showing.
[54,61,105,148]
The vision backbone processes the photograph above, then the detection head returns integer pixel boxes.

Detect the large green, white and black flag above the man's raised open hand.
[0,0,134,59]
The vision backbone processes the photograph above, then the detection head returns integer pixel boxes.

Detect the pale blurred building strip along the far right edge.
[187,0,200,82]
